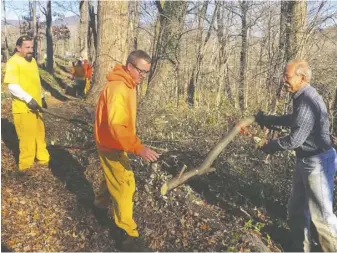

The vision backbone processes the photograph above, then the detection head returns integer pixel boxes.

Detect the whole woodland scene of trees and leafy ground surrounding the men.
[1,0,337,251]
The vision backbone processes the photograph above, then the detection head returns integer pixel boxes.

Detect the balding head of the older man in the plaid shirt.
[283,60,311,93]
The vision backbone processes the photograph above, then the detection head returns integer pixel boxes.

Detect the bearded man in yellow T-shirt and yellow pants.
[4,36,49,175]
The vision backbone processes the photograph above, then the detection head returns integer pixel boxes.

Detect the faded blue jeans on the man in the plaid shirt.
[288,148,337,252]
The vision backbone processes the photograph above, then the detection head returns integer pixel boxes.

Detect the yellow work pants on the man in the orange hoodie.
[95,150,139,237]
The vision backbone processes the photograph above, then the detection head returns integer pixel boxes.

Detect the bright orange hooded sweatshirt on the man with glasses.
[95,64,144,154]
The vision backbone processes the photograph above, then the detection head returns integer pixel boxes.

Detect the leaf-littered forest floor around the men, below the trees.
[1,59,334,252]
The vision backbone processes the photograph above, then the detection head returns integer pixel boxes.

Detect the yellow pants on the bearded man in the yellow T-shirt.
[13,112,49,171]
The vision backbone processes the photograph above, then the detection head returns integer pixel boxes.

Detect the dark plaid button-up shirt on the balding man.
[267,84,331,157]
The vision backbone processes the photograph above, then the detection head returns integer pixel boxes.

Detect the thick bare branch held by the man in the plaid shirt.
[160,116,255,195]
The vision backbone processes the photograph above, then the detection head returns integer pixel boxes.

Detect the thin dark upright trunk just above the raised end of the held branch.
[239,1,248,111]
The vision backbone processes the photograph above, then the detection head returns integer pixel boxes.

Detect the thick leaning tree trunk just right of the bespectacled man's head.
[146,1,187,105]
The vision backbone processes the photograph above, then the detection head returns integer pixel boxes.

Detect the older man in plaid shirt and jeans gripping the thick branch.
[256,60,337,252]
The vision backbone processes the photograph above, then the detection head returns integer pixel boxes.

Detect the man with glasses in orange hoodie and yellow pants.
[95,50,159,251]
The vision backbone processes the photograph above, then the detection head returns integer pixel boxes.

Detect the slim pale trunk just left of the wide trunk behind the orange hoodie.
[80,0,88,59]
